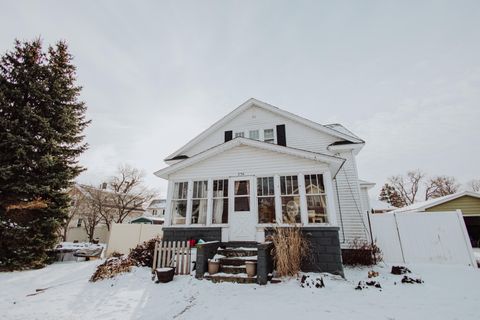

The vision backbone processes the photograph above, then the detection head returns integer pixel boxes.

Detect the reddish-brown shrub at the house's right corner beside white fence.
[342,239,382,266]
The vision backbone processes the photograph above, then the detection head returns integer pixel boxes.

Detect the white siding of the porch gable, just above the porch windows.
[169,146,328,180]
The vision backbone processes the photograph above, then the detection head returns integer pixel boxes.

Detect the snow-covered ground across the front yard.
[0,261,480,320]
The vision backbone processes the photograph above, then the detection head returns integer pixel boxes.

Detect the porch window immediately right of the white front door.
[257,177,275,223]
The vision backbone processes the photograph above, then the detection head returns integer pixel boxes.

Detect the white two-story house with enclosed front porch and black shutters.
[155,99,373,271]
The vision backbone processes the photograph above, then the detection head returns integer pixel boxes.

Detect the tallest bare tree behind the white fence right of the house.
[388,170,425,206]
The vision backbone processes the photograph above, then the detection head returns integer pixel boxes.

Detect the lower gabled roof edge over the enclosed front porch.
[154,138,345,179]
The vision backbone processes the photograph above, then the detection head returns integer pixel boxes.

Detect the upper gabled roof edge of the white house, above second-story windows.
[165,98,365,161]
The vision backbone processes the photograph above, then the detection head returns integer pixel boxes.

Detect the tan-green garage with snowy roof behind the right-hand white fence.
[393,191,480,247]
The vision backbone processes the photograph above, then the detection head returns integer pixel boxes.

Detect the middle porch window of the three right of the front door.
[280,176,300,223]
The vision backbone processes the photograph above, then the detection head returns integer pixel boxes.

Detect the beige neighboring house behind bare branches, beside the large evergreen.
[66,183,144,243]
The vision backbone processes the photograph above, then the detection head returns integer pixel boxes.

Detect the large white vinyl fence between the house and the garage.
[370,210,476,266]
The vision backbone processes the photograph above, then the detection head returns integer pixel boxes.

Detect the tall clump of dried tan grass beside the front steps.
[272,227,310,277]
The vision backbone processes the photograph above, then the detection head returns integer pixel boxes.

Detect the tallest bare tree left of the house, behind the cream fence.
[108,165,153,223]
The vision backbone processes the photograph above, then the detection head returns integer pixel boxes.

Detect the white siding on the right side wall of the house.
[333,152,368,248]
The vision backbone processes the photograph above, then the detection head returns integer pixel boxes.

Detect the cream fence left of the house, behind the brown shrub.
[106,223,163,257]
